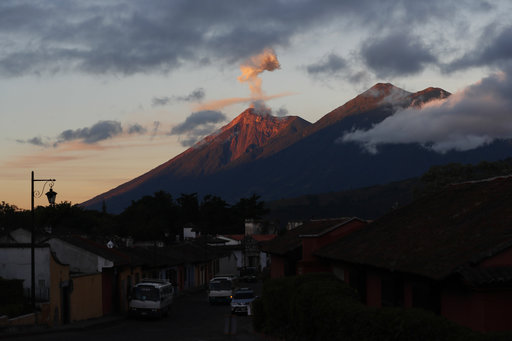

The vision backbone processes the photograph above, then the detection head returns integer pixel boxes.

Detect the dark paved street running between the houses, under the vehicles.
[4,284,266,341]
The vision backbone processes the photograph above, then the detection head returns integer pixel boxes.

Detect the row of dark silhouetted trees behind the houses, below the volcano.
[0,191,268,240]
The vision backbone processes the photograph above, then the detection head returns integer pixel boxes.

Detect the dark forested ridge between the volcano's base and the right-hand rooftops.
[266,158,512,224]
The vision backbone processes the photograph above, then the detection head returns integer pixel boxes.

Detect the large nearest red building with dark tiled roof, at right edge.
[315,177,512,331]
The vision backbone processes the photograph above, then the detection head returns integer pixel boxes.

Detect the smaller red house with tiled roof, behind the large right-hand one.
[262,218,366,278]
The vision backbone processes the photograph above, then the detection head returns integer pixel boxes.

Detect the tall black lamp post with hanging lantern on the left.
[30,171,57,310]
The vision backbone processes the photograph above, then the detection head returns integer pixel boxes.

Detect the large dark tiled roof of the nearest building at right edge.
[315,177,512,279]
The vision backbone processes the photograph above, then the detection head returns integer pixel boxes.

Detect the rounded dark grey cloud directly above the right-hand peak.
[361,32,437,78]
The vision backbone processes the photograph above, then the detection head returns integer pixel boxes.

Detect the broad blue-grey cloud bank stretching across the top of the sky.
[0,0,492,76]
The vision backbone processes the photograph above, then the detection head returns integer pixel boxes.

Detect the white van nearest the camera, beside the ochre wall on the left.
[129,279,174,317]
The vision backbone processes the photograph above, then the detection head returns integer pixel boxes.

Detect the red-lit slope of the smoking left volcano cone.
[82,108,311,208]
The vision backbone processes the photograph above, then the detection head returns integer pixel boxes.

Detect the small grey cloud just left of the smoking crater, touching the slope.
[171,110,227,147]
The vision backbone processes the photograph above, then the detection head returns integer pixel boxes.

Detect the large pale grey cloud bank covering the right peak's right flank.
[338,68,512,153]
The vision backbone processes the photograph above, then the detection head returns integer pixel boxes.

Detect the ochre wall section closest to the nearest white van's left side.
[71,273,103,321]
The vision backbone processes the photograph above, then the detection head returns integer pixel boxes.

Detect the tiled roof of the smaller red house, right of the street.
[262,218,358,255]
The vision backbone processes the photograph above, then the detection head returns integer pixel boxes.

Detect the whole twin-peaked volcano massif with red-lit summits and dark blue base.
[82,83,512,213]
